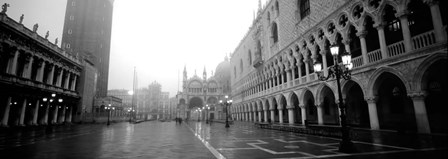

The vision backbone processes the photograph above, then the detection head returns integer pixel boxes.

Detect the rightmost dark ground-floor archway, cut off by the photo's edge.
[422,59,448,133]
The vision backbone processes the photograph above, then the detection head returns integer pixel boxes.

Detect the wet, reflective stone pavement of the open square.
[0,121,448,159]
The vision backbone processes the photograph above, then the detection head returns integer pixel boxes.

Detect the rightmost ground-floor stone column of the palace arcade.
[410,93,431,134]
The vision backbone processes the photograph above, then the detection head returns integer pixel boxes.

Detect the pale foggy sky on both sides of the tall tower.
[0,0,265,96]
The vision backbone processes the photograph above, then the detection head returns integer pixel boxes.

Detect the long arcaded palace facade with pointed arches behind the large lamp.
[230,0,448,133]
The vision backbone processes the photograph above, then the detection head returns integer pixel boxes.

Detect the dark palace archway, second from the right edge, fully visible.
[373,72,416,131]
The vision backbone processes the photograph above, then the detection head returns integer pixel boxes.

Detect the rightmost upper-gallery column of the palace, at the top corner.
[429,1,446,42]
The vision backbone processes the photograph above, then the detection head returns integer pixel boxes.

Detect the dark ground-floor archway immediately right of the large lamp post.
[343,80,370,128]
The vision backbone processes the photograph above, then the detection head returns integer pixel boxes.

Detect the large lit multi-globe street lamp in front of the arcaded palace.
[313,45,356,152]
